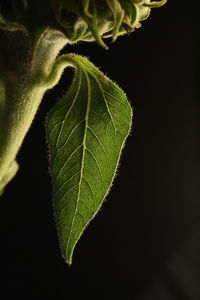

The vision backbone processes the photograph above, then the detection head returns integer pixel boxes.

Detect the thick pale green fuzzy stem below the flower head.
[0,30,66,191]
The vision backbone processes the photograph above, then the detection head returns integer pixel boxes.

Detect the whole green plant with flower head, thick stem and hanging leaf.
[0,0,166,264]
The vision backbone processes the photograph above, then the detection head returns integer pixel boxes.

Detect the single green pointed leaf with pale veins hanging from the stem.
[47,54,132,264]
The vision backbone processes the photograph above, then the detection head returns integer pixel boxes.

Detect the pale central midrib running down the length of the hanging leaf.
[66,69,91,255]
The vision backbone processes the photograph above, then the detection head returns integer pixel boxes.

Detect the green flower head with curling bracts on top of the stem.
[0,0,166,48]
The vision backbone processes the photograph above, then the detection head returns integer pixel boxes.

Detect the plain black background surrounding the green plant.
[0,0,200,300]
